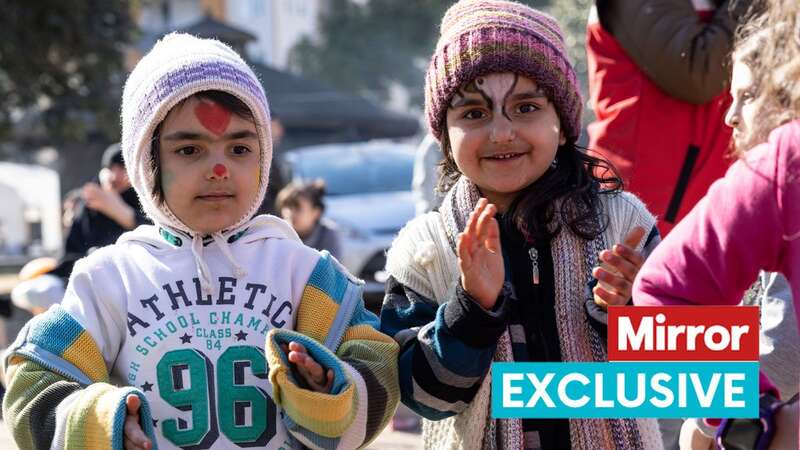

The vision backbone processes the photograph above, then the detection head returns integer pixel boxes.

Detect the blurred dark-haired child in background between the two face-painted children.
[275,180,342,259]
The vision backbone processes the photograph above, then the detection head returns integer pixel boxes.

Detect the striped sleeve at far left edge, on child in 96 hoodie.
[3,306,155,450]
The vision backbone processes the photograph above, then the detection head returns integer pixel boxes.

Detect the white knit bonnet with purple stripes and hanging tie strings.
[122,33,272,293]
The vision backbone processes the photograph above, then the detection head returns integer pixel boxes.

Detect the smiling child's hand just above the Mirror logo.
[592,227,645,308]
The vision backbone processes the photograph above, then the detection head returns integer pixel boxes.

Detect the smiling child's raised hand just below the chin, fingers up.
[458,198,505,310]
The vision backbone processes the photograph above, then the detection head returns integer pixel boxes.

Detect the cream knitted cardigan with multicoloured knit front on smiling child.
[386,180,663,450]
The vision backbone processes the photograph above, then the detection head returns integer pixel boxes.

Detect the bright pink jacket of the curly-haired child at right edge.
[633,120,800,328]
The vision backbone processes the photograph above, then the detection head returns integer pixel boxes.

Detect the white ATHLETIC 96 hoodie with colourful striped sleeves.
[4,216,398,450]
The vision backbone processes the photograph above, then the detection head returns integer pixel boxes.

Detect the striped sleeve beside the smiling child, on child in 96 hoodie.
[266,253,400,449]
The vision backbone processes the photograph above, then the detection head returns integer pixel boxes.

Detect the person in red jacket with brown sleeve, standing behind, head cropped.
[586,0,750,236]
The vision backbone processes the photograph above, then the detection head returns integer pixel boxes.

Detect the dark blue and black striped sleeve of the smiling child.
[381,277,511,420]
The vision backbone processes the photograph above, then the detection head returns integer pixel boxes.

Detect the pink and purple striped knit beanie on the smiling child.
[425,0,583,141]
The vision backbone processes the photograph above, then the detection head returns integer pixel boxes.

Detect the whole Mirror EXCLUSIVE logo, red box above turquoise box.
[492,306,759,418]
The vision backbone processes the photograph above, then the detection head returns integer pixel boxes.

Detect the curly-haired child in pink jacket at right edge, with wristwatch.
[633,0,800,449]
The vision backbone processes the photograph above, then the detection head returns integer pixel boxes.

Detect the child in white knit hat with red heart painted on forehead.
[3,34,398,449]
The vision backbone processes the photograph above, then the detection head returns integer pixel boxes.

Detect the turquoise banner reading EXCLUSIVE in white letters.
[492,362,758,419]
